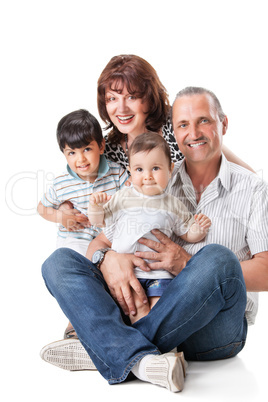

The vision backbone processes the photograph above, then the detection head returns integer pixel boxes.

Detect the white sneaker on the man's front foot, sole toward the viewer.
[145,352,186,392]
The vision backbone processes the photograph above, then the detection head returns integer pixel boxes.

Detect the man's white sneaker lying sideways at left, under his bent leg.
[40,339,97,371]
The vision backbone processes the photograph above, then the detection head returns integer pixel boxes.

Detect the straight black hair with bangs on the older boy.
[57,109,103,152]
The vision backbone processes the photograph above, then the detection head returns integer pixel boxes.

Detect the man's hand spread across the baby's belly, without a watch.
[135,229,191,276]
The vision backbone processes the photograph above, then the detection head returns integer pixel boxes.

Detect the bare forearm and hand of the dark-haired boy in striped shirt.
[37,201,88,232]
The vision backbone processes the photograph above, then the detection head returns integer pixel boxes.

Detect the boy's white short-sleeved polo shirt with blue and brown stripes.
[41,155,128,241]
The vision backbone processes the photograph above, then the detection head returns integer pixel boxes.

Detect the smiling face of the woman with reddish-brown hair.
[105,86,148,136]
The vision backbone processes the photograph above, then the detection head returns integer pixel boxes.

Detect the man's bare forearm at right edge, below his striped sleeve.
[241,251,268,292]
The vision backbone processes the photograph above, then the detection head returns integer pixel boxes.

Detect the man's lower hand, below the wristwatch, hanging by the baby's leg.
[100,250,150,315]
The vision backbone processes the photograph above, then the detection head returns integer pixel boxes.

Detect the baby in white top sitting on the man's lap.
[88,133,211,323]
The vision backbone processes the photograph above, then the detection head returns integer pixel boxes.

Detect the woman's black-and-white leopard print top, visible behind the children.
[104,119,184,169]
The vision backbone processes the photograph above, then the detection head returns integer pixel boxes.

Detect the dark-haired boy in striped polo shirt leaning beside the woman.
[37,109,128,255]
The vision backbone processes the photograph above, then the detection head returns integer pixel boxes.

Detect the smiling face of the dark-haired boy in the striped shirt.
[63,140,105,183]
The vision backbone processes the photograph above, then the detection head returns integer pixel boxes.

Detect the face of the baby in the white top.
[130,148,173,196]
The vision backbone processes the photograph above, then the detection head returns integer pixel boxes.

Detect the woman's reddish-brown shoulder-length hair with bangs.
[97,55,170,143]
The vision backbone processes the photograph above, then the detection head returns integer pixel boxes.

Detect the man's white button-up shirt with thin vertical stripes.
[167,155,268,324]
